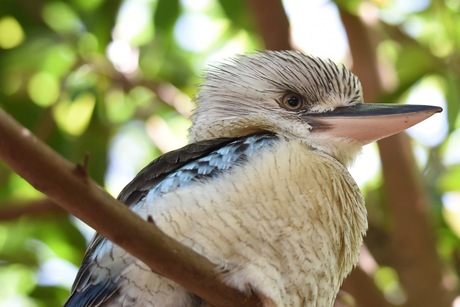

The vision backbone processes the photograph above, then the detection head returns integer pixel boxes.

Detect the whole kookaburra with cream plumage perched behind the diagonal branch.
[66,51,441,307]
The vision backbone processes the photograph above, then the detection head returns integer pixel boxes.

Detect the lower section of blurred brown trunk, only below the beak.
[379,134,452,307]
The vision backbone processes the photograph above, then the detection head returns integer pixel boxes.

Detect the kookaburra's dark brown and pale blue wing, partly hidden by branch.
[65,134,275,306]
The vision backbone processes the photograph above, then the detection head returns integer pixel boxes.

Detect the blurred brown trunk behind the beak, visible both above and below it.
[341,7,449,306]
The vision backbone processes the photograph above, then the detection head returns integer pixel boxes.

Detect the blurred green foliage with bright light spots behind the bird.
[0,0,460,306]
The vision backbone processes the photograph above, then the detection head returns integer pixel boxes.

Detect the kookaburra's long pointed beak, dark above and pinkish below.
[304,103,442,144]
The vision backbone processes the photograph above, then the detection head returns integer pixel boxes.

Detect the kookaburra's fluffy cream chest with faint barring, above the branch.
[147,141,367,306]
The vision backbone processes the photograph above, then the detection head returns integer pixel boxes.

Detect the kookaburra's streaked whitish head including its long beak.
[190,51,441,164]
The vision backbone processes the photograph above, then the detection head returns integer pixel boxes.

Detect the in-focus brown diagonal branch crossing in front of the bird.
[0,109,260,306]
